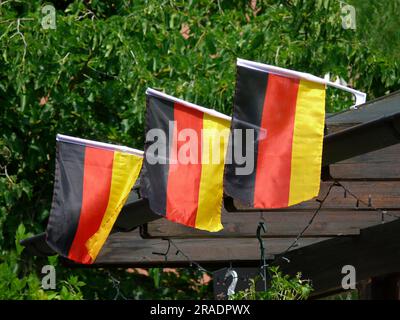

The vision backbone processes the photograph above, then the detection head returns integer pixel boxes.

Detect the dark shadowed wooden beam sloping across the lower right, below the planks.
[275,219,400,295]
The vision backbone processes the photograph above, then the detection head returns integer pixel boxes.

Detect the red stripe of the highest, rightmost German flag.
[254,74,299,208]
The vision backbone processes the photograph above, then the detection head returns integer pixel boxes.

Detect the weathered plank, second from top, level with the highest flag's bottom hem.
[235,181,400,211]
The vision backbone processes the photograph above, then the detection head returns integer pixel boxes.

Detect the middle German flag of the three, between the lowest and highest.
[140,89,230,231]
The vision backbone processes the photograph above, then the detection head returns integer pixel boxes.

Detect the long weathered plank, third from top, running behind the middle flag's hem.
[142,210,400,238]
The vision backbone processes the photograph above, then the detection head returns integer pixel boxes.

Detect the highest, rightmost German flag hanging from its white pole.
[224,59,325,208]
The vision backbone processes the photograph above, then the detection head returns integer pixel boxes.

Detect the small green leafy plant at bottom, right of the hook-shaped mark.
[229,267,312,300]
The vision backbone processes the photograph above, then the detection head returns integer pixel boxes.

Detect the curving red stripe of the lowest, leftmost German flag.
[68,147,114,263]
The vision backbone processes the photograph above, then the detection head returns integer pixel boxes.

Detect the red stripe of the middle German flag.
[166,103,203,227]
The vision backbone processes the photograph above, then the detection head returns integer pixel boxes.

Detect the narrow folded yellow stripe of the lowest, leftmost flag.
[86,151,143,261]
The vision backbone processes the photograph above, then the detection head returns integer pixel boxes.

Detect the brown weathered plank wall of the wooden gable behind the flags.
[97,138,400,272]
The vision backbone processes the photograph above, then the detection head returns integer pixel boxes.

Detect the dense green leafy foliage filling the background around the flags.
[0,0,400,299]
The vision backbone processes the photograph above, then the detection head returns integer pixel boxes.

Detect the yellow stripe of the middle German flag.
[195,114,230,232]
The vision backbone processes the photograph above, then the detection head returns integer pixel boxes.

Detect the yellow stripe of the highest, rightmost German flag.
[289,80,325,206]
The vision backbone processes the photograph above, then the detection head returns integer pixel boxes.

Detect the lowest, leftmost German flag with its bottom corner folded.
[46,135,143,264]
